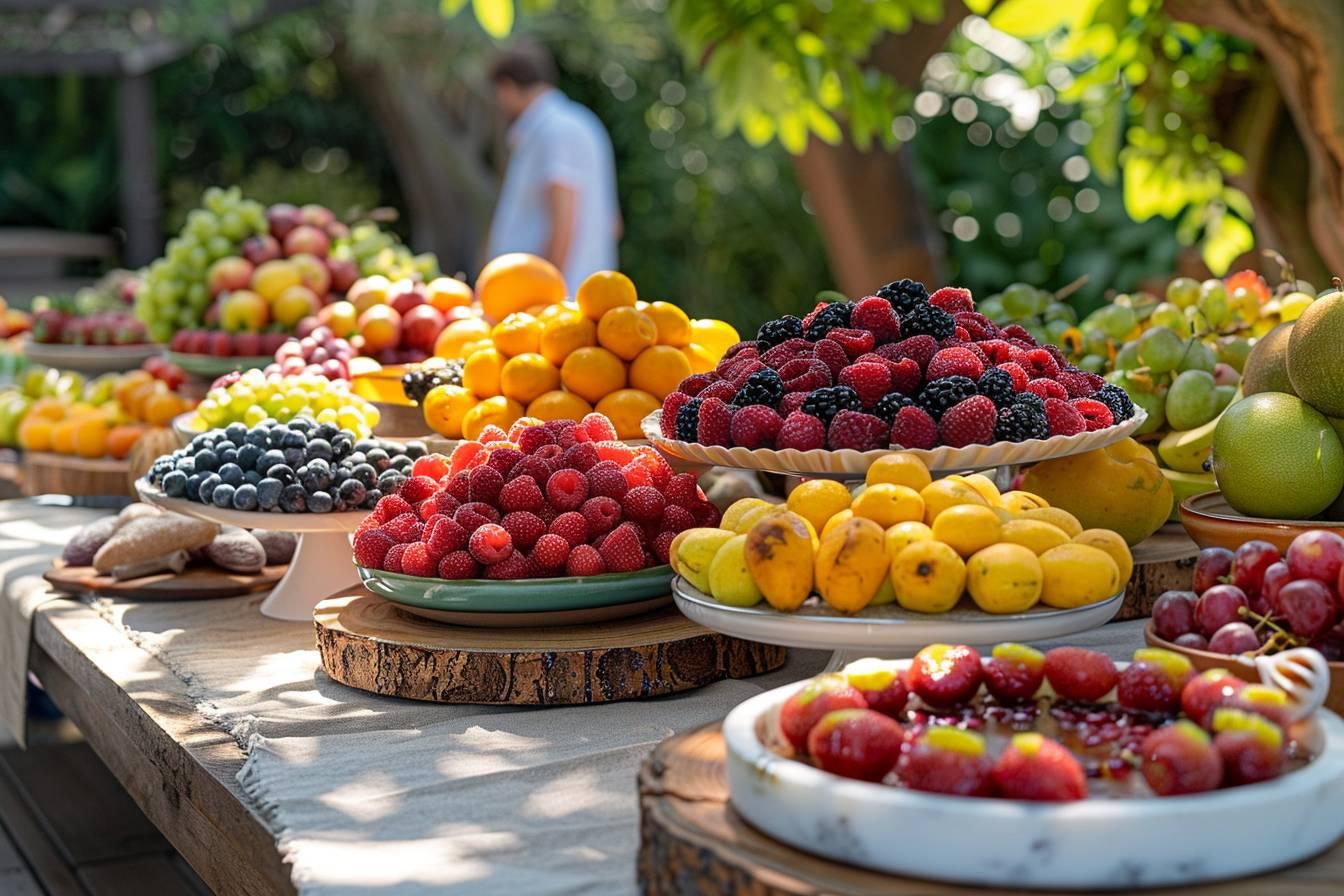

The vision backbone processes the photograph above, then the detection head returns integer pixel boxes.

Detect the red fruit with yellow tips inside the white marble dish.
[778,643,1304,802]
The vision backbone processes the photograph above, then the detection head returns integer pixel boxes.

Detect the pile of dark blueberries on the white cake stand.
[148,416,426,513]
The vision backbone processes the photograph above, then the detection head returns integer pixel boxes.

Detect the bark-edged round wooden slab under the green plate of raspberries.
[313,592,786,705]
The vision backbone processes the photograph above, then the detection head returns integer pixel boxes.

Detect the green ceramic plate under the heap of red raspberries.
[359,566,672,613]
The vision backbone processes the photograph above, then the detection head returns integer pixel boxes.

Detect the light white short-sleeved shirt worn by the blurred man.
[489,90,621,296]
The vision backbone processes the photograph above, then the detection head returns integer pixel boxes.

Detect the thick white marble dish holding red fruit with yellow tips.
[723,664,1344,891]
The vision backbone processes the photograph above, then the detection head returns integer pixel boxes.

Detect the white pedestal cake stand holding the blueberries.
[136,480,368,622]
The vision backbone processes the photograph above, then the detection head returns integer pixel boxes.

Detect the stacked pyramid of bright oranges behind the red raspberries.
[422,271,739,439]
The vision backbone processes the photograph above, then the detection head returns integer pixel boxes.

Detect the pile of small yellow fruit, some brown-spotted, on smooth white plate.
[671,454,1133,614]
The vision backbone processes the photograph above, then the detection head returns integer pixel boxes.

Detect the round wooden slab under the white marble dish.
[637,724,1344,896]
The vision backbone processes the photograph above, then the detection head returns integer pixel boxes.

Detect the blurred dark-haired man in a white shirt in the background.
[489,44,621,296]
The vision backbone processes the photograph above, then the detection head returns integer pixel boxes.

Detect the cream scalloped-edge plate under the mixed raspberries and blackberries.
[642,407,1148,478]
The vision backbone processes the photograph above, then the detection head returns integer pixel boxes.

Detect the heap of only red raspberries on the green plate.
[355,414,719,579]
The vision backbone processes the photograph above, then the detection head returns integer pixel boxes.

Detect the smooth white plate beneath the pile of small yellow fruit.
[672,576,1125,652]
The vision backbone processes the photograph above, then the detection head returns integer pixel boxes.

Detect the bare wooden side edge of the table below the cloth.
[30,600,294,896]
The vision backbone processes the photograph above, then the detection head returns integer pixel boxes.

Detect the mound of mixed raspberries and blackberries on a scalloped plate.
[661,279,1134,451]
